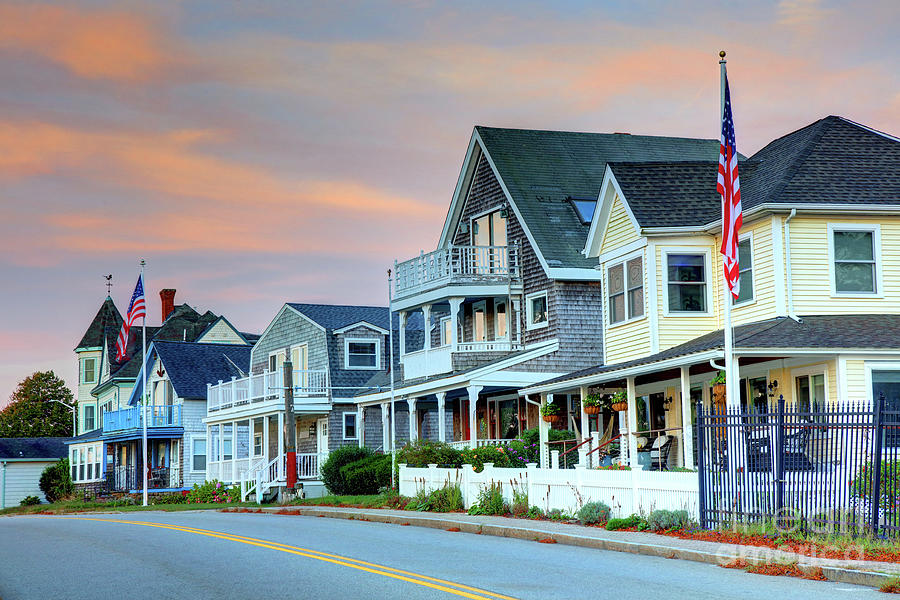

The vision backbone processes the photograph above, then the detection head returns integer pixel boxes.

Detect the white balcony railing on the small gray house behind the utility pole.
[206,369,329,412]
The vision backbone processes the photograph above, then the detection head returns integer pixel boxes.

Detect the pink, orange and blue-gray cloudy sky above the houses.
[0,0,900,404]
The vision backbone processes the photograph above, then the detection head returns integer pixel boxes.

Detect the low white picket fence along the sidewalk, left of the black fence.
[399,463,700,519]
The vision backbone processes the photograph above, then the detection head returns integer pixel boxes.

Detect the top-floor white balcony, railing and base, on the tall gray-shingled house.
[393,245,520,310]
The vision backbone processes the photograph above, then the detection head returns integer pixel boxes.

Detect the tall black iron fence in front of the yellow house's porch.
[697,397,900,537]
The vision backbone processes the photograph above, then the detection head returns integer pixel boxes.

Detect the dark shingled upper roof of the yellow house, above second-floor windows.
[609,116,900,227]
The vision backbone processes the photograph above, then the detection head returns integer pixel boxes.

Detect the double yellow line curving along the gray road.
[69,517,516,600]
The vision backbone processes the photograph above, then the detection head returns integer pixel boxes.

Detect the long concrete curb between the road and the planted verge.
[251,506,897,588]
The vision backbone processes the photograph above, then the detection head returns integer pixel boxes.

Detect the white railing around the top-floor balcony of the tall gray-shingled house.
[394,246,519,298]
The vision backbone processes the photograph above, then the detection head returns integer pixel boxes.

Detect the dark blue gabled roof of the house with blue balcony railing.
[148,341,251,400]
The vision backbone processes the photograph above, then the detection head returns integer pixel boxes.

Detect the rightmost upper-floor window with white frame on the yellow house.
[828,225,880,294]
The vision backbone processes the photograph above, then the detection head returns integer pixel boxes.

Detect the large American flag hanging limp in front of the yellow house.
[716,75,743,299]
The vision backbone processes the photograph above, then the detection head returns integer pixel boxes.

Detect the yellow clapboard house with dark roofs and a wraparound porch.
[523,116,900,466]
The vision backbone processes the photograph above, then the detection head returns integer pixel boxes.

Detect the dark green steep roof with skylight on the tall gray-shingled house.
[475,125,719,269]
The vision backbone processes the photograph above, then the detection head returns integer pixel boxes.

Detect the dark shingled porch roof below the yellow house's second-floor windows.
[526,314,900,391]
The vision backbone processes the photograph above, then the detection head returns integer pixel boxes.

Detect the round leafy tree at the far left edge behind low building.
[0,371,75,437]
